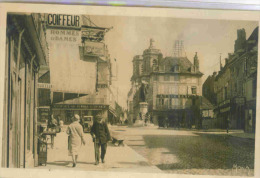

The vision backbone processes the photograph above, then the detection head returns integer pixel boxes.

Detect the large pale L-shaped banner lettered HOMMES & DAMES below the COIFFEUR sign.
[47,27,96,94]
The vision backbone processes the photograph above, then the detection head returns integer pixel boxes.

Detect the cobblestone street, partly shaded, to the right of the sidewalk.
[121,128,254,176]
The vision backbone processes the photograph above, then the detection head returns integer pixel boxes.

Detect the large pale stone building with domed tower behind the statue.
[129,39,203,127]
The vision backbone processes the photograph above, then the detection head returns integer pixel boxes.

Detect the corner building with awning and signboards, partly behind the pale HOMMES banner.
[47,25,118,123]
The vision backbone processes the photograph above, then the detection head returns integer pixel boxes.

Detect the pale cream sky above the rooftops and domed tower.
[89,16,258,108]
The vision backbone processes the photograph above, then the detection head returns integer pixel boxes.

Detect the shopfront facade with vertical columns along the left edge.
[1,13,48,168]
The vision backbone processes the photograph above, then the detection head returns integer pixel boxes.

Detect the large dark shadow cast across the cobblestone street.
[141,134,254,170]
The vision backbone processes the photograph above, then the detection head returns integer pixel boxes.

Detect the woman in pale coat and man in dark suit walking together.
[66,114,111,167]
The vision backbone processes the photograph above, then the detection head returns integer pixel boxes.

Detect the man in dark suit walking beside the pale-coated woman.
[90,114,111,165]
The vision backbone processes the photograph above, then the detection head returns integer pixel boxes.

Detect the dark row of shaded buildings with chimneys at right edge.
[214,27,258,132]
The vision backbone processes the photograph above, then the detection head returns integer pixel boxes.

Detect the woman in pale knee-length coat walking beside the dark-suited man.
[67,114,85,167]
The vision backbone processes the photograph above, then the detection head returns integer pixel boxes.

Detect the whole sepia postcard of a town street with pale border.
[0,3,259,177]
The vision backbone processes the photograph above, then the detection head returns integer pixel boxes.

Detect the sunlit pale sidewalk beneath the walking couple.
[36,128,162,173]
